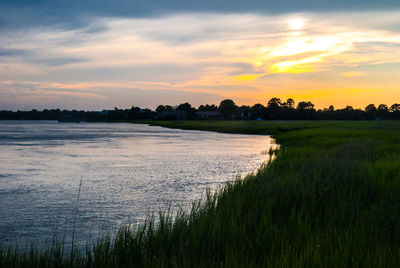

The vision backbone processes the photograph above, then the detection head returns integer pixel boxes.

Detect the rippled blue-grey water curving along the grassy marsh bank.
[0,121,277,247]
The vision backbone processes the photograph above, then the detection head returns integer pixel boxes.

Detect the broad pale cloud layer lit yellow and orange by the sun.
[0,11,400,107]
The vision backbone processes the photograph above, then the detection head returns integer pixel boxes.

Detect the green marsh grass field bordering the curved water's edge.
[0,121,400,267]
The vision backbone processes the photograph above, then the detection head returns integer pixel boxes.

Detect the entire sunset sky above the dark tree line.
[0,0,400,110]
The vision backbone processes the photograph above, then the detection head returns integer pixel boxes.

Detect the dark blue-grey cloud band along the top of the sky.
[0,0,400,28]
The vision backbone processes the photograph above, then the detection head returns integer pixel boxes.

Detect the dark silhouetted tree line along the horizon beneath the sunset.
[0,98,400,122]
